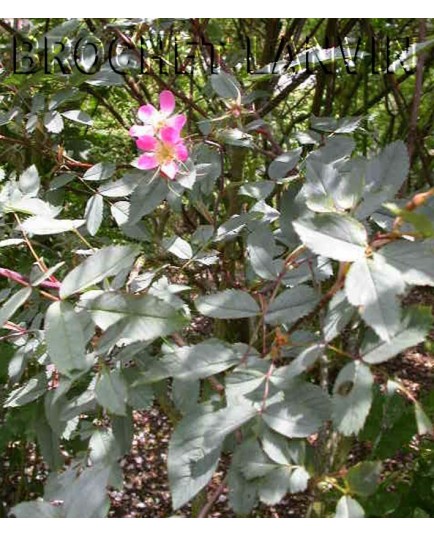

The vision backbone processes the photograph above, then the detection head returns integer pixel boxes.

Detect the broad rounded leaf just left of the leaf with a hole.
[262,382,330,437]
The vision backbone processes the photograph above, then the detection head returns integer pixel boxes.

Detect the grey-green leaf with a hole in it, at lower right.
[332,361,374,436]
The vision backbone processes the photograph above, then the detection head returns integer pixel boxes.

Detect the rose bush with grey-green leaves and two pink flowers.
[0,17,434,517]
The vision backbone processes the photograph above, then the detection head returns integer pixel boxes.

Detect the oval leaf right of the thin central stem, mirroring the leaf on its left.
[265,285,318,325]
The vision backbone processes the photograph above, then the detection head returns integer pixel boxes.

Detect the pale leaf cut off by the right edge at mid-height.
[378,240,434,287]
